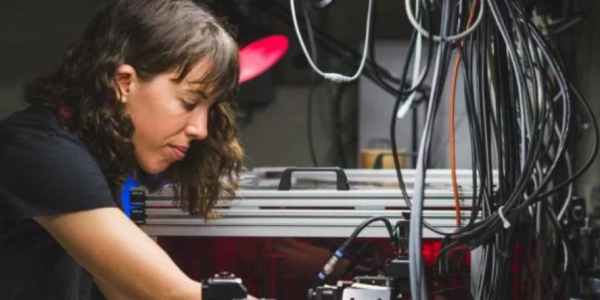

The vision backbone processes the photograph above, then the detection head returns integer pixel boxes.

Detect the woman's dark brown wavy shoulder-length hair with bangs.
[25,0,243,216]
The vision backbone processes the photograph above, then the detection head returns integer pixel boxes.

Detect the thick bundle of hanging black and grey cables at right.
[390,0,598,299]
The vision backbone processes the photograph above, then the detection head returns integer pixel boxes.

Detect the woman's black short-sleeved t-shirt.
[0,105,116,300]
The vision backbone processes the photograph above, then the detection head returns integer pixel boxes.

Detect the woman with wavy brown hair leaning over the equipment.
[0,0,242,300]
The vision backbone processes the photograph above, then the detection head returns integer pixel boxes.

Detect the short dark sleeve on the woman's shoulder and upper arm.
[0,124,117,219]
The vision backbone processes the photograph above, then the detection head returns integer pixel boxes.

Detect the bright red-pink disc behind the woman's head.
[239,35,289,83]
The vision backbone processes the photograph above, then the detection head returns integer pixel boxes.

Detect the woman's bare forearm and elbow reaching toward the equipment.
[34,208,202,300]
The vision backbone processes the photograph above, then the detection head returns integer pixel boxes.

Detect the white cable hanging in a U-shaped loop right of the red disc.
[290,0,373,82]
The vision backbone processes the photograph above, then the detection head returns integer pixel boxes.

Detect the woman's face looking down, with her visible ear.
[116,64,215,174]
